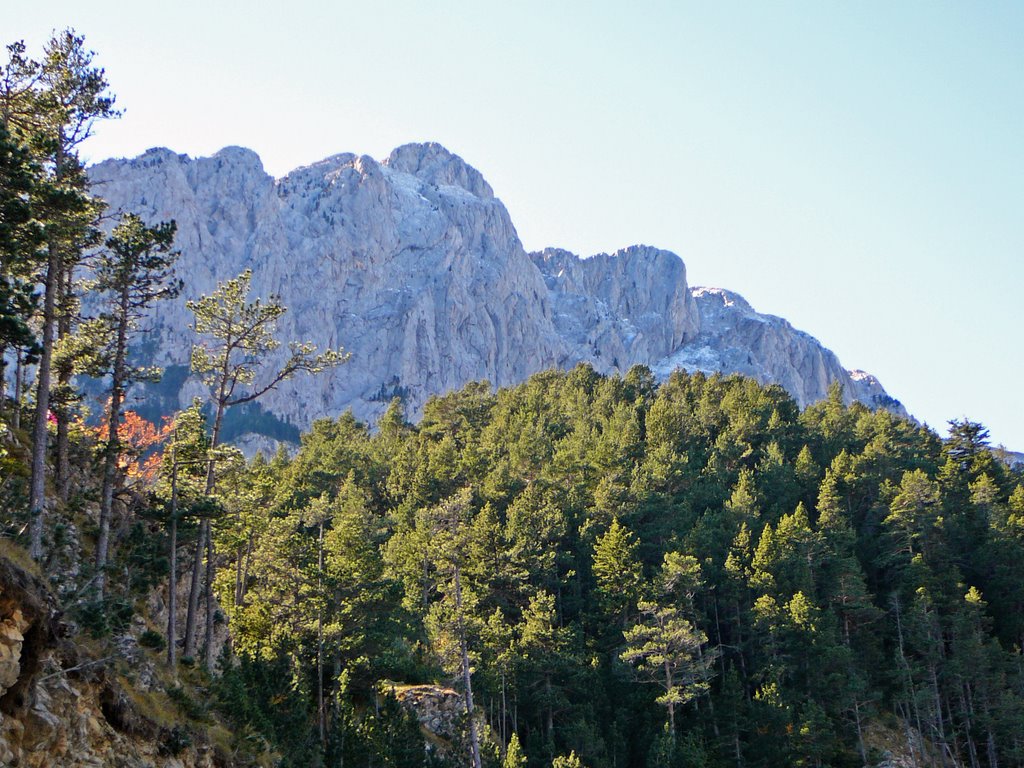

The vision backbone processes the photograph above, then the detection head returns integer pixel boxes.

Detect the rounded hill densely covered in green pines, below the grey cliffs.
[192,367,1024,766]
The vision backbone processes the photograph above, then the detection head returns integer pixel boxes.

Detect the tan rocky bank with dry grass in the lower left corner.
[0,552,228,768]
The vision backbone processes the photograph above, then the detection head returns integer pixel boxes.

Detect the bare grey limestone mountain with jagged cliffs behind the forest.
[90,143,903,437]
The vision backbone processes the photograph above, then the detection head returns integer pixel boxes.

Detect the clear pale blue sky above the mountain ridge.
[8,0,1024,451]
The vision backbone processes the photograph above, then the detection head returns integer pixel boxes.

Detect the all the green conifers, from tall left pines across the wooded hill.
[0,27,1024,768]
